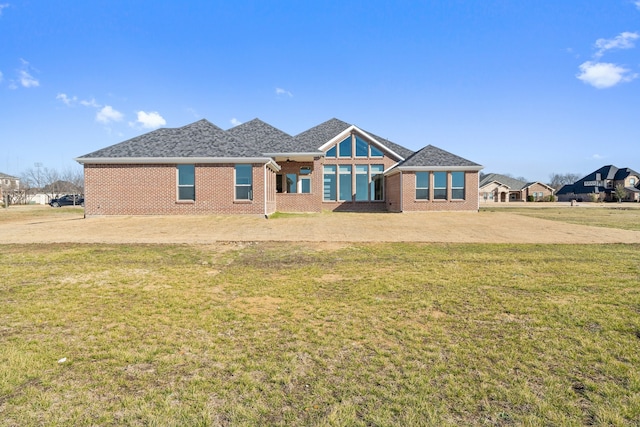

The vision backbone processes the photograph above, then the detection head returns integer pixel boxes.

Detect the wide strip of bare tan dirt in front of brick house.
[0,208,640,244]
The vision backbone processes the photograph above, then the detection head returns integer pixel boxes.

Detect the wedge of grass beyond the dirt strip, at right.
[481,203,640,231]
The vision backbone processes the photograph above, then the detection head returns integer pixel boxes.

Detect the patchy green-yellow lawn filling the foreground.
[0,243,640,426]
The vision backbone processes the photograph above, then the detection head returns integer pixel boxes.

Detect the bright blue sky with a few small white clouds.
[0,0,640,181]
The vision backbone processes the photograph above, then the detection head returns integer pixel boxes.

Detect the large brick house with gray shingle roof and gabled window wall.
[76,119,482,216]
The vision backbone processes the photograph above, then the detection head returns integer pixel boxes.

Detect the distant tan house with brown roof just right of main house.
[479,173,554,203]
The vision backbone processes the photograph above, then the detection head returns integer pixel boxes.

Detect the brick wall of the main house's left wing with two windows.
[84,164,268,216]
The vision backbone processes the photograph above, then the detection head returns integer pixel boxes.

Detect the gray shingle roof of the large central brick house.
[77,118,482,170]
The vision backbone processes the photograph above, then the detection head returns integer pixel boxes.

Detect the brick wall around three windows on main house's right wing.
[402,171,479,212]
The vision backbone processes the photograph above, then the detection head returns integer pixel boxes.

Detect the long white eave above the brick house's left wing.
[74,157,280,171]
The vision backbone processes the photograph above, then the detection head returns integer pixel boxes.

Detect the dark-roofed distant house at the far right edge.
[556,165,640,202]
